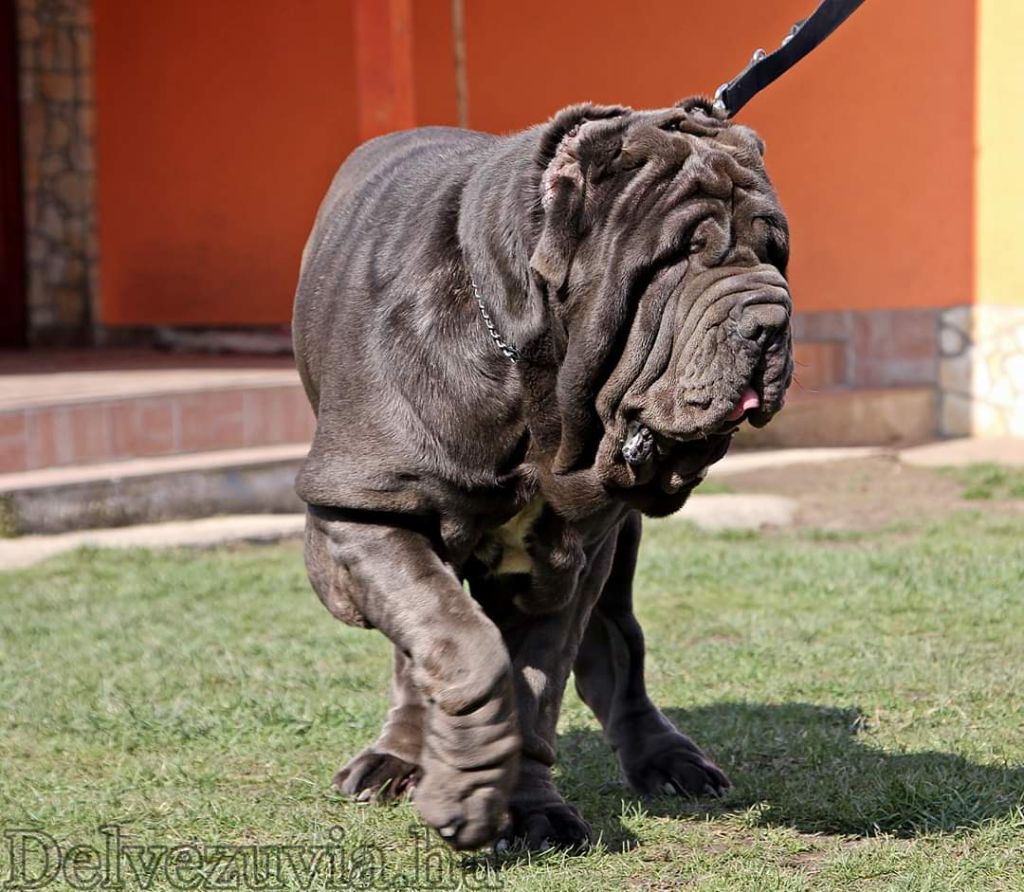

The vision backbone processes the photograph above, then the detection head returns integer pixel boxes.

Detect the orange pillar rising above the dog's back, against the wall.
[353,0,416,140]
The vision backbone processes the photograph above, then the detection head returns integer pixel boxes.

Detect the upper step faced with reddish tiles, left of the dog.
[0,358,314,473]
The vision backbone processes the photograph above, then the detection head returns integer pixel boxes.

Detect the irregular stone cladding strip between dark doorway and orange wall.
[16,0,97,343]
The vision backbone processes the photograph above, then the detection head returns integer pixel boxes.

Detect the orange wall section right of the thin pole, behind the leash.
[466,0,975,310]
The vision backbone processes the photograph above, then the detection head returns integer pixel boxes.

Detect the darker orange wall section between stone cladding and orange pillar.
[93,0,356,325]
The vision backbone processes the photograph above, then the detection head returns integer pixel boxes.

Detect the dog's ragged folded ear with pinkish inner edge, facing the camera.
[529,104,630,291]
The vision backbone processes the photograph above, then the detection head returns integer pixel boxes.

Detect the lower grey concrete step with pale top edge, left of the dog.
[0,442,308,536]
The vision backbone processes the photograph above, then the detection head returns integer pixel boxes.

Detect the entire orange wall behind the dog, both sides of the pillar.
[94,0,975,325]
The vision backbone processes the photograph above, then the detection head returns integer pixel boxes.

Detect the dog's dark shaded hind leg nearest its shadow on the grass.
[573,513,729,796]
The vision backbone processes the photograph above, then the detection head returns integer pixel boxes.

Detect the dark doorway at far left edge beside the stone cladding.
[0,0,28,347]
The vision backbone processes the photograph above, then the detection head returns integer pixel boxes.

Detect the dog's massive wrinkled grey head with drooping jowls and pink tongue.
[530,99,793,513]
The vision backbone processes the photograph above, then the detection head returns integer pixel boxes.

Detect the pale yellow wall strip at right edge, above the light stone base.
[974,0,1024,306]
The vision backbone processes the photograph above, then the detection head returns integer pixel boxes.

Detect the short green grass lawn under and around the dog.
[0,513,1024,892]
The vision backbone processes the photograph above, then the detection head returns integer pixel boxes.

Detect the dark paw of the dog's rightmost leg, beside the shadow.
[621,732,732,797]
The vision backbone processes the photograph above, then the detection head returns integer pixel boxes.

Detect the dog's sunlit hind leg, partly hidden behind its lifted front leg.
[334,647,427,802]
